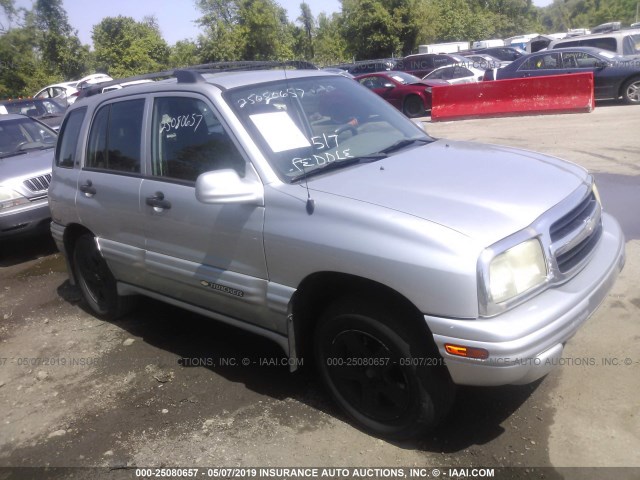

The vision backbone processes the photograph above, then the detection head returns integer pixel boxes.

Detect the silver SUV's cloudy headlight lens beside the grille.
[488,238,547,303]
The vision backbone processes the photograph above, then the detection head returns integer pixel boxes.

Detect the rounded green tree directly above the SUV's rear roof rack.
[92,16,169,77]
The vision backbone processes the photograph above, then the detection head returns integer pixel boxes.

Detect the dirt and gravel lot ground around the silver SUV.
[0,103,640,479]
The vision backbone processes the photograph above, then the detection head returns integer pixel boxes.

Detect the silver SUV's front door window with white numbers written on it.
[151,97,245,182]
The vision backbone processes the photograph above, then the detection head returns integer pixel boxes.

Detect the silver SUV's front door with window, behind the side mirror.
[140,94,272,328]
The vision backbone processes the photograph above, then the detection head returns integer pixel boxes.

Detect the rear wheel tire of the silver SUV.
[73,234,133,320]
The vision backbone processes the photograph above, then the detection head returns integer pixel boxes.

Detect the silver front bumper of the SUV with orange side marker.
[424,215,625,386]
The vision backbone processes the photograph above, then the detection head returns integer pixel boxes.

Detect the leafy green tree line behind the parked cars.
[0,0,638,98]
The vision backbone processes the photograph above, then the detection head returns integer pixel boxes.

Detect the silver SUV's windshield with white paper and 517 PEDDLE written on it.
[225,76,432,182]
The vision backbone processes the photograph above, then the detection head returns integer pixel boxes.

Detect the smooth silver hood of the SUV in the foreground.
[309,140,589,245]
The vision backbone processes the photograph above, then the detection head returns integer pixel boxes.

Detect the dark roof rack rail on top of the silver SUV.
[78,60,318,98]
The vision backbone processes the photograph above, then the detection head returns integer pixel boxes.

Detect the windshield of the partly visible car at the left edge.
[0,118,56,157]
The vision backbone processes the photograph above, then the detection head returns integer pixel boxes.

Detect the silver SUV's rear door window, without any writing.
[85,99,144,173]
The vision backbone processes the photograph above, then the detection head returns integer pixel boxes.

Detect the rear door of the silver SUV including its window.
[76,97,145,283]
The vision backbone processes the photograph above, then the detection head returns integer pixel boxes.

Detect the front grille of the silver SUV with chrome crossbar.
[549,192,602,274]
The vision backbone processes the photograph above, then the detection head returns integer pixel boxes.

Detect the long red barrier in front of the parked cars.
[431,72,595,122]
